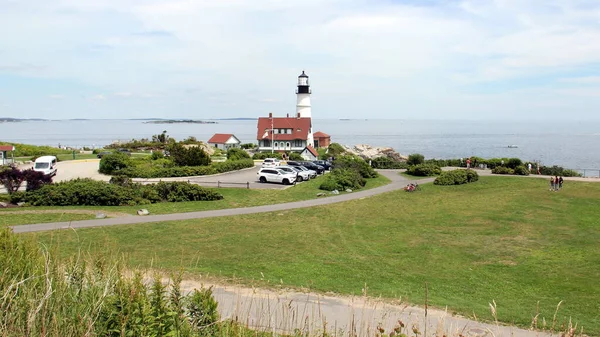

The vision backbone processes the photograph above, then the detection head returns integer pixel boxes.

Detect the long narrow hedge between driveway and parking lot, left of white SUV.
[113,159,254,178]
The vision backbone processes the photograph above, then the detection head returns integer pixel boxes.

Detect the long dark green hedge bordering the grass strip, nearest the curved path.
[24,179,223,206]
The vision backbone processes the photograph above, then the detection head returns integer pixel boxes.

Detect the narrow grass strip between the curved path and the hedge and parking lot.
[0,175,390,216]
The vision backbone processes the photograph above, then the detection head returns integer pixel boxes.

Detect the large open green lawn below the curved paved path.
[34,177,600,335]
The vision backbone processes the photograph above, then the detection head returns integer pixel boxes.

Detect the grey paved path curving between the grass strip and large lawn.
[11,170,418,233]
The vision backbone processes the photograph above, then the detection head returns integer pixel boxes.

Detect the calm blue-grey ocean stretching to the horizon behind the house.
[0,119,600,170]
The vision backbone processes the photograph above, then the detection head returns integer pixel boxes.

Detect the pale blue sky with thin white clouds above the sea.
[0,0,600,121]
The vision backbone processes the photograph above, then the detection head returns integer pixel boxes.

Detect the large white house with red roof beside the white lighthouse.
[256,113,313,152]
